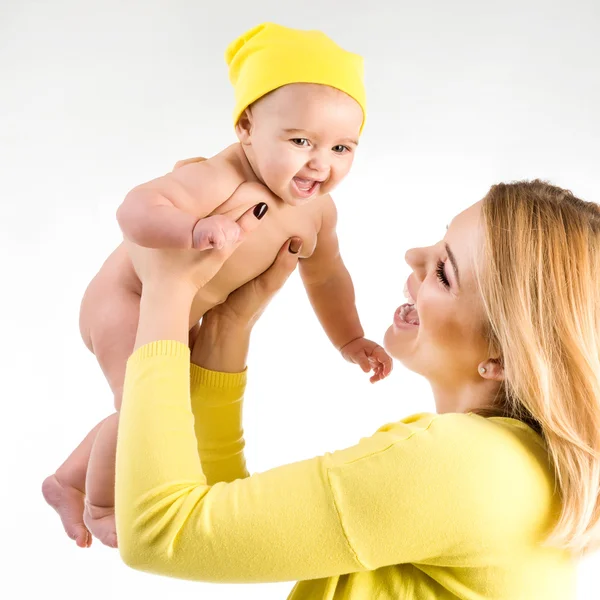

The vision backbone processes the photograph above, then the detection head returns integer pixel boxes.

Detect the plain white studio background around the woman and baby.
[0,0,600,600]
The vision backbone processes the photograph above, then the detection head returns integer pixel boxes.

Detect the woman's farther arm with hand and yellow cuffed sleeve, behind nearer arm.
[190,238,302,485]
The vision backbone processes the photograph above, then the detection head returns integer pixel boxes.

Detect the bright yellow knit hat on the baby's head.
[225,23,366,132]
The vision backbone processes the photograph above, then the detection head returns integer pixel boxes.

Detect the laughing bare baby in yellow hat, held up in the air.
[43,23,392,547]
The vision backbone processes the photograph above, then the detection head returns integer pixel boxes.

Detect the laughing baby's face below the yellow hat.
[238,83,363,206]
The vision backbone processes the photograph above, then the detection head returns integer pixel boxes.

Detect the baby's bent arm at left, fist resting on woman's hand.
[117,161,242,249]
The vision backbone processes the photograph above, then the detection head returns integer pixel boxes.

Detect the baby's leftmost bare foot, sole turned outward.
[42,475,92,548]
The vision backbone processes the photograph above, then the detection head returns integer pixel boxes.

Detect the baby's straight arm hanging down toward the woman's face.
[300,196,392,383]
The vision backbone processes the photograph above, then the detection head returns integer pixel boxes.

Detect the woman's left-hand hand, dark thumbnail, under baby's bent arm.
[125,202,268,295]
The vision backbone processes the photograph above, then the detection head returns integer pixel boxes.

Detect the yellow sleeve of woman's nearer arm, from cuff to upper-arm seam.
[115,341,361,583]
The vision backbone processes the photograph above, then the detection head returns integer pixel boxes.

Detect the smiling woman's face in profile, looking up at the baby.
[384,202,488,389]
